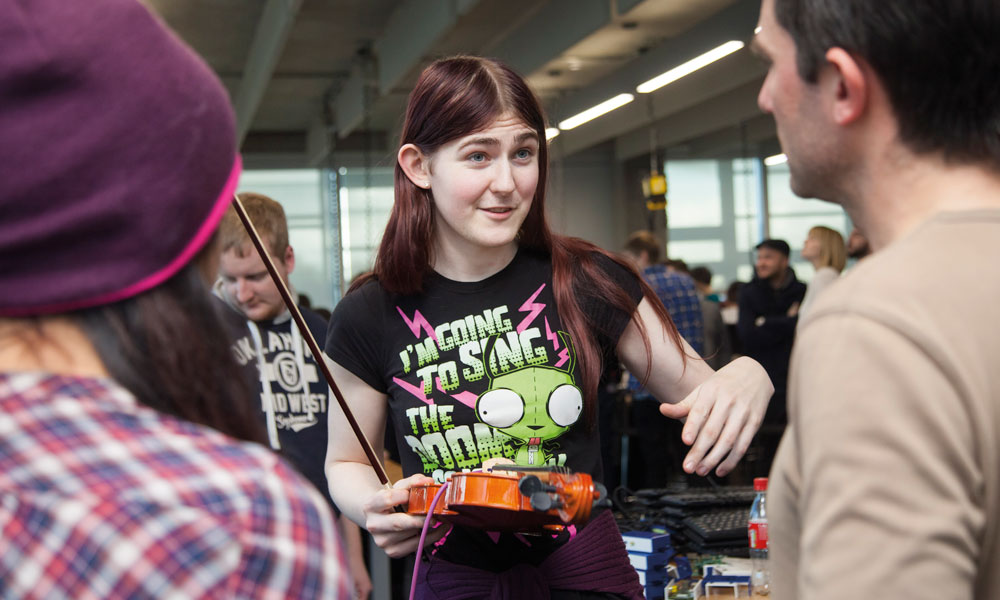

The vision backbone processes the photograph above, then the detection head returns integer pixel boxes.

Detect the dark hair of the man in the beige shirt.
[774,0,1000,168]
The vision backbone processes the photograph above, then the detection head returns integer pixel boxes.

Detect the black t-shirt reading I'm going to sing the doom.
[326,249,641,481]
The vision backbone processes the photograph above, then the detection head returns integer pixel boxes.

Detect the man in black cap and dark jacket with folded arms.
[737,239,806,475]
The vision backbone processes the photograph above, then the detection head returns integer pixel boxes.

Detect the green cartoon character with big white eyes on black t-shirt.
[476,331,583,466]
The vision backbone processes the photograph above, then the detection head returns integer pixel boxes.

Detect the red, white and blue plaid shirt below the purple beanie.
[0,373,352,599]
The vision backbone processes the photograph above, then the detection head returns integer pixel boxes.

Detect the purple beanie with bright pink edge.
[0,0,240,317]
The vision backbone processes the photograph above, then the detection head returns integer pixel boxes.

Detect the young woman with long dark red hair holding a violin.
[326,57,772,598]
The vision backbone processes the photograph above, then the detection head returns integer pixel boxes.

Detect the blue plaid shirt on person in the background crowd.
[628,265,705,398]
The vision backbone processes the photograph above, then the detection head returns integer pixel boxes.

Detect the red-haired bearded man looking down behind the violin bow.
[215,192,372,599]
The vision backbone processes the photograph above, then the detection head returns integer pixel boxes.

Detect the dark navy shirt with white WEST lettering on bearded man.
[231,307,339,506]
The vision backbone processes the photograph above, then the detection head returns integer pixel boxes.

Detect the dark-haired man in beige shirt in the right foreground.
[753,0,1000,600]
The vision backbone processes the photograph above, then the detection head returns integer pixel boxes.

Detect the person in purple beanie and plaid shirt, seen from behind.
[0,0,350,599]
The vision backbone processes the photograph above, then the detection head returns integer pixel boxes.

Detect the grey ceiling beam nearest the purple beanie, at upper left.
[233,0,302,144]
